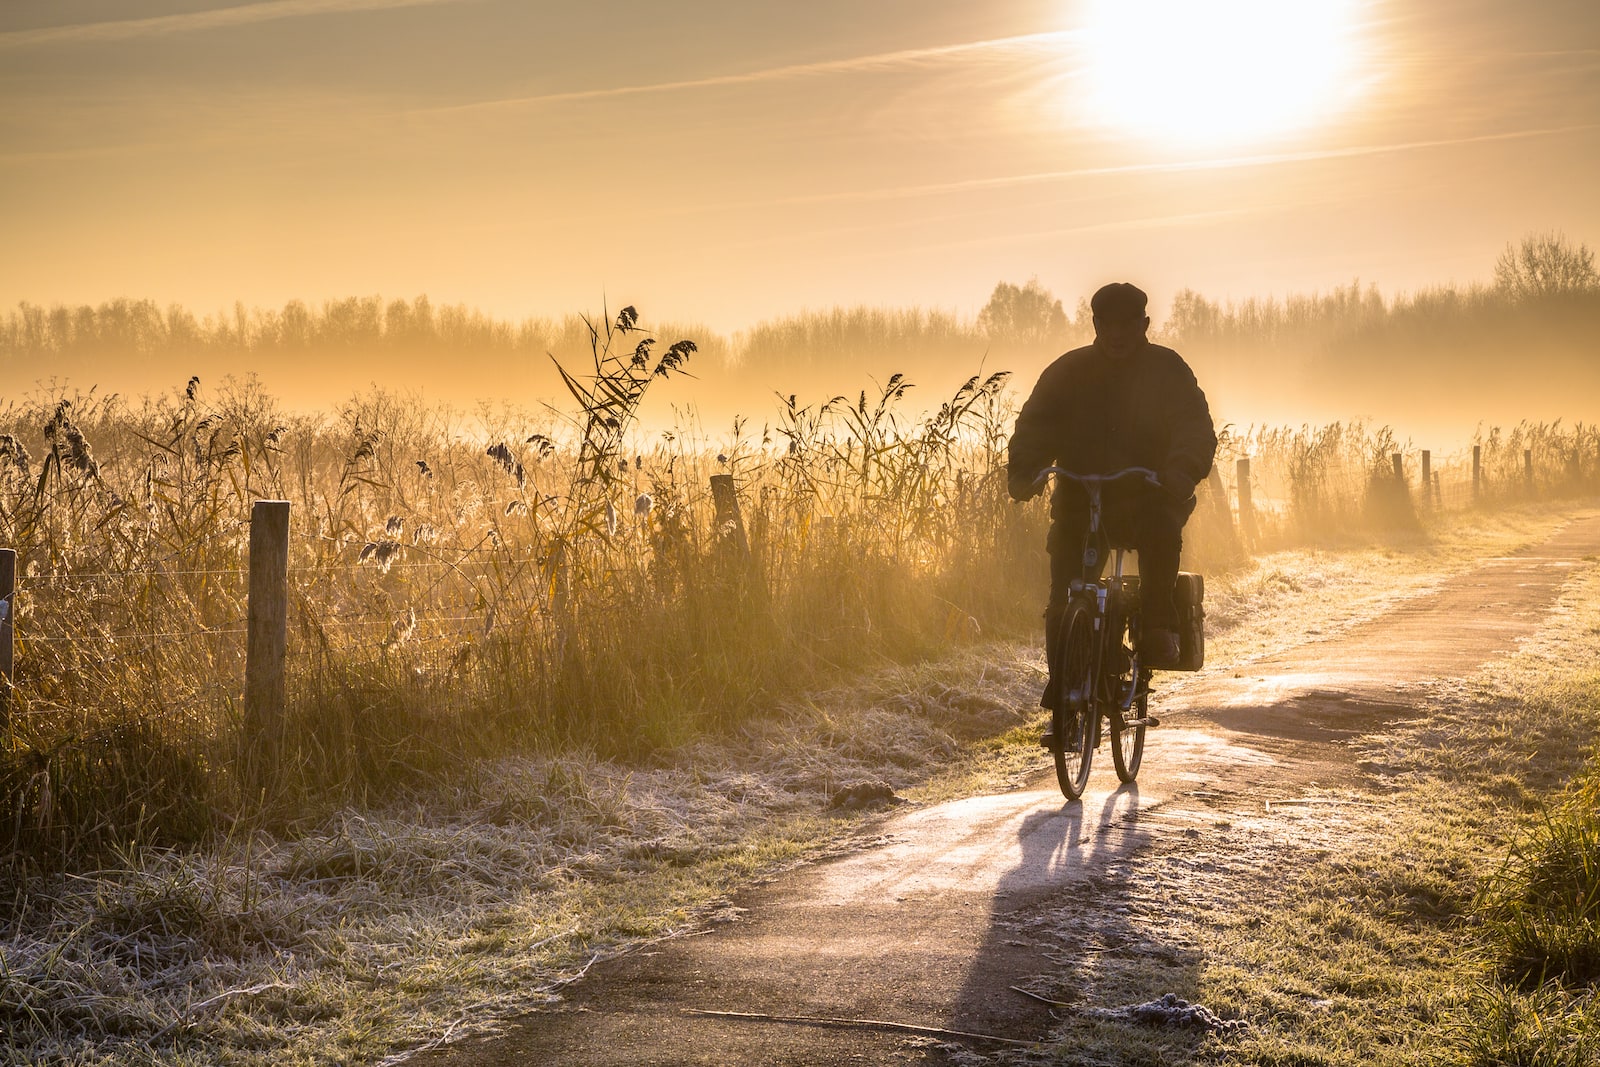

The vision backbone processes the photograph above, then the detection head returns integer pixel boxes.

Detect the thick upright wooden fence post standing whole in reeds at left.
[245,501,290,785]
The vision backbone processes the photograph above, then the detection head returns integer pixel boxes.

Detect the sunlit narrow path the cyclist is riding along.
[410,515,1600,1067]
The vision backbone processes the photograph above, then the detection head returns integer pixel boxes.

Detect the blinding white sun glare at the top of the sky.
[1077,0,1358,147]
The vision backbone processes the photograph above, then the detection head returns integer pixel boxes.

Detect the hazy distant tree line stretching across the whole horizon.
[0,232,1600,414]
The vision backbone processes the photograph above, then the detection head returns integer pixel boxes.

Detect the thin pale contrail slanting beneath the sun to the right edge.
[776,122,1600,205]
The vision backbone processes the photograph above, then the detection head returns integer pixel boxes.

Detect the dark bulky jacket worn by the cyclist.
[1006,344,1216,518]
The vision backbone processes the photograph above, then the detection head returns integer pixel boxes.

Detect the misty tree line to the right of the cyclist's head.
[1160,234,1600,418]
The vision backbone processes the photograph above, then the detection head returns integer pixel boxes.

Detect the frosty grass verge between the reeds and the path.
[0,510,1587,1064]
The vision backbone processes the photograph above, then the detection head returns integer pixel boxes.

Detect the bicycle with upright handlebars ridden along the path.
[1038,467,1160,800]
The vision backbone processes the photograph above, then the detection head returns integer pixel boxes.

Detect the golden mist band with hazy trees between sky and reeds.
[9,234,1600,448]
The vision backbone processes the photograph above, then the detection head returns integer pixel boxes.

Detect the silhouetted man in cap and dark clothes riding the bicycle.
[1006,282,1216,707]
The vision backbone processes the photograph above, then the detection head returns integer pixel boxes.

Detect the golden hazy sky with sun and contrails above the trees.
[0,0,1600,331]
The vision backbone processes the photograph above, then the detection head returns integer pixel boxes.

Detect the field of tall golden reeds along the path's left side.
[0,299,1600,867]
